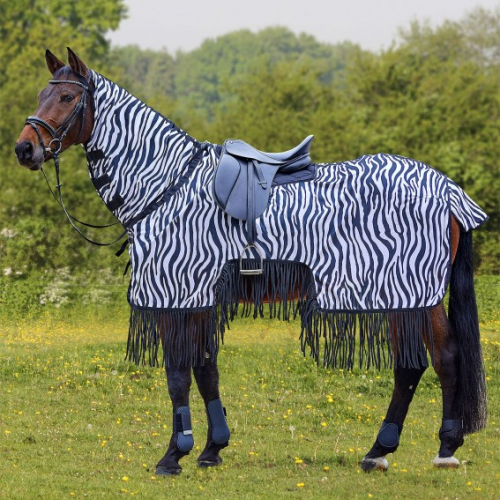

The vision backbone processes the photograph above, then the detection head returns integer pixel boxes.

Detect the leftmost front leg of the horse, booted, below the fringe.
[155,366,194,476]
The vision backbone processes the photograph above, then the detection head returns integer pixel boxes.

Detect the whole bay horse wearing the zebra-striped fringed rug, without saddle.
[15,48,487,475]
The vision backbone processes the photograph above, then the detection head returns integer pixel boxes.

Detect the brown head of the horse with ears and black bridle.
[15,47,94,170]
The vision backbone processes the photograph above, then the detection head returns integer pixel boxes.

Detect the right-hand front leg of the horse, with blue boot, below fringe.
[193,360,231,467]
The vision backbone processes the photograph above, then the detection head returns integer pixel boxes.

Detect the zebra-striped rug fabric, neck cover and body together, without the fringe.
[83,72,487,368]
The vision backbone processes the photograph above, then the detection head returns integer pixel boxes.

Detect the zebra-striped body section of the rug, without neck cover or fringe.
[124,154,484,311]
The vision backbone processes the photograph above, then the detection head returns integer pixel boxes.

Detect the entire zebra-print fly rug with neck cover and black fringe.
[85,68,487,368]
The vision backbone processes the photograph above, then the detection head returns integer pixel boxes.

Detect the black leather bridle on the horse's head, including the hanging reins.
[26,80,127,247]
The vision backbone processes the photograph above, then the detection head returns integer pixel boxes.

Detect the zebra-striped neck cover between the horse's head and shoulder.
[86,71,200,224]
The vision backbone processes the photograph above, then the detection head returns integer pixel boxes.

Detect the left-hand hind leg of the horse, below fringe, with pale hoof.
[361,367,426,472]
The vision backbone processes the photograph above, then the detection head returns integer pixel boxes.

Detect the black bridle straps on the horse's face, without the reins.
[26,80,93,159]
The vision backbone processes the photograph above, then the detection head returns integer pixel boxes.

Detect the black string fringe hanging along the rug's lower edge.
[127,260,433,370]
